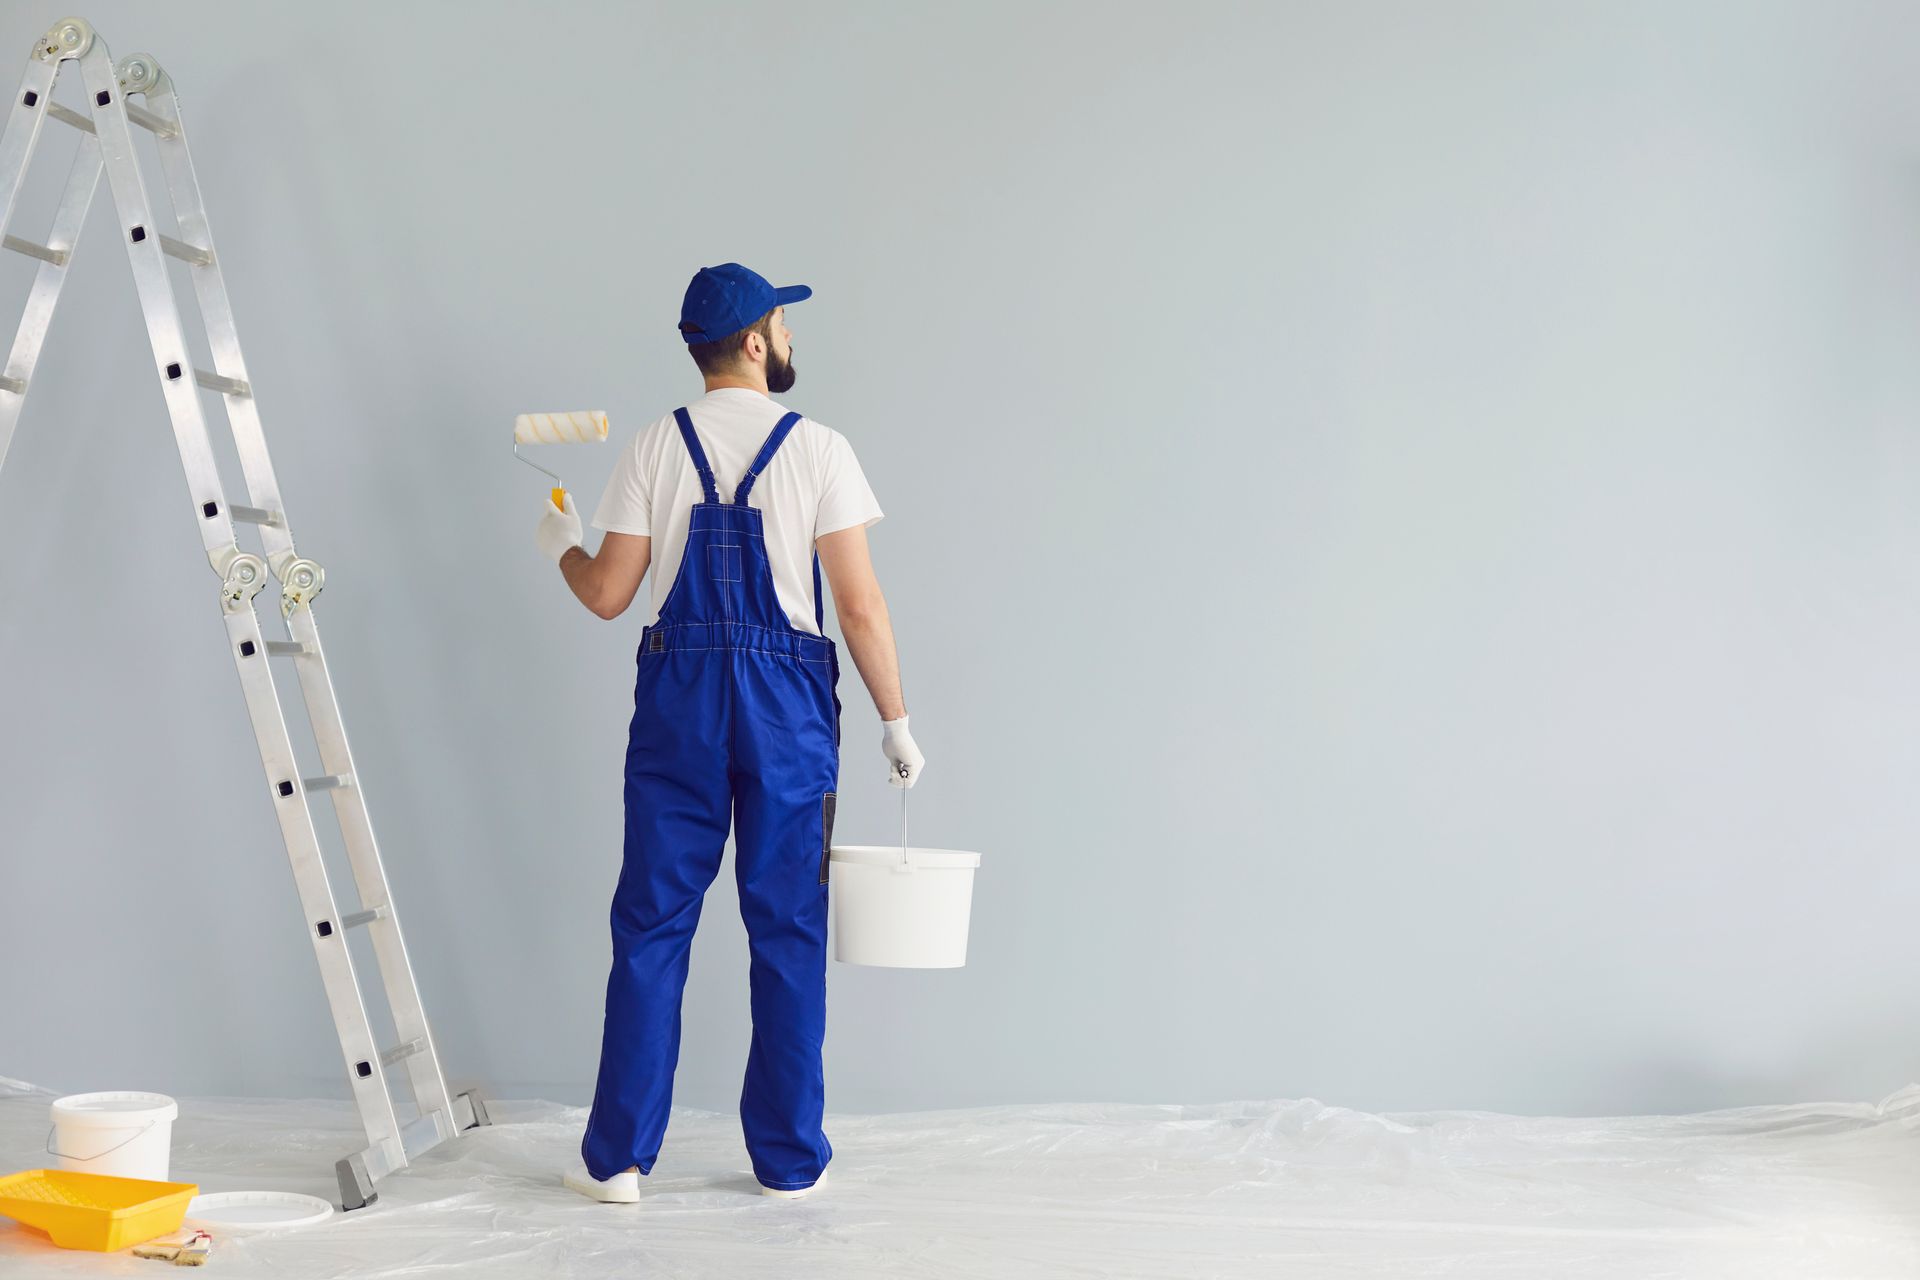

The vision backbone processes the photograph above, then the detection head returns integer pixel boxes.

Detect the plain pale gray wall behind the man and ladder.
[0,0,1920,1113]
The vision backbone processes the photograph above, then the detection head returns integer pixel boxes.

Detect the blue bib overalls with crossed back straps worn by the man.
[580,409,841,1190]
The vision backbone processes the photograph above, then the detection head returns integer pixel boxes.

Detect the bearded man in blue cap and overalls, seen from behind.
[536,263,925,1203]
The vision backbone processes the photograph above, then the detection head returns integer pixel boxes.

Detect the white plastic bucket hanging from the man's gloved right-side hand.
[828,844,979,969]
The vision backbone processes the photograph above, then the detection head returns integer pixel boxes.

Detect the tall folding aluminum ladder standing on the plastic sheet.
[0,17,488,1209]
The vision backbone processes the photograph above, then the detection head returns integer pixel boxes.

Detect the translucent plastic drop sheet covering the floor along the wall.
[0,1077,1920,1280]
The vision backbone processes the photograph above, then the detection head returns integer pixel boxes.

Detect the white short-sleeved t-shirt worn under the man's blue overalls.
[593,388,885,635]
